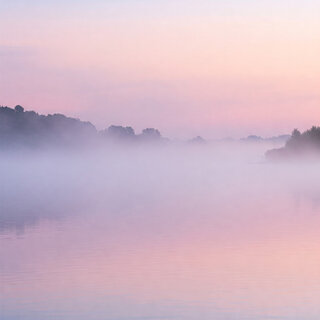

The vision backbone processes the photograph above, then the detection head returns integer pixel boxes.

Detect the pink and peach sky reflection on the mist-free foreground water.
[0,175,320,319]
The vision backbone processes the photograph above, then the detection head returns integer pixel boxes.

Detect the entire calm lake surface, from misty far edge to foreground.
[0,146,320,320]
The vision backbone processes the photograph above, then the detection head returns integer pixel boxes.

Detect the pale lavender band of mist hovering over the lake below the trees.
[0,141,318,231]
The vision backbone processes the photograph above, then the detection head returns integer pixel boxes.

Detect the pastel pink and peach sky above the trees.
[0,0,320,138]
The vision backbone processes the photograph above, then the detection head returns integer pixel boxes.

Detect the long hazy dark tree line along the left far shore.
[0,105,167,149]
